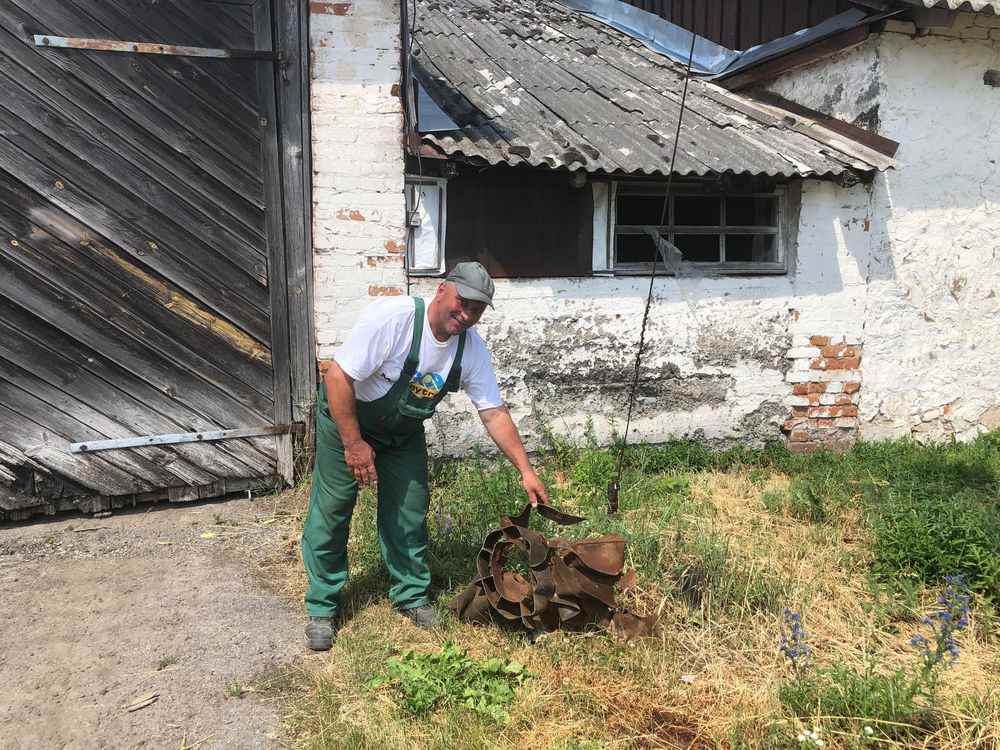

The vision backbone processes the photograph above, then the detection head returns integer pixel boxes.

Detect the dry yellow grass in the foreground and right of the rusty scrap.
[250,473,1000,750]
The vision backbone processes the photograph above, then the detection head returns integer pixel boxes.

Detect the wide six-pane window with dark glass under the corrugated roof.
[609,182,786,273]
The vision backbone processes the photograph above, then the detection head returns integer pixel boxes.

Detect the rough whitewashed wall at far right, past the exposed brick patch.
[769,13,1000,439]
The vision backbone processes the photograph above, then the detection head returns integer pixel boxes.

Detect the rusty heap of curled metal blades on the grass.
[448,505,653,638]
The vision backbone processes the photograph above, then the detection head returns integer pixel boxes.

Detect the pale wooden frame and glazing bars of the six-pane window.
[595,180,798,276]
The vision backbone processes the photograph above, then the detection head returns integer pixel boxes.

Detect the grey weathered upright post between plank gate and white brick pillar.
[254,0,316,485]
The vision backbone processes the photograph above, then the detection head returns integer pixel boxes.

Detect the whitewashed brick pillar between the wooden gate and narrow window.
[309,0,406,359]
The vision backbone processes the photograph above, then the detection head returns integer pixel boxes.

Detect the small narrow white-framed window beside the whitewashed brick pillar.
[406,176,447,275]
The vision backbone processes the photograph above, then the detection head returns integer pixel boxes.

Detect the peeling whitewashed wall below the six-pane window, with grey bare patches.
[413,173,872,454]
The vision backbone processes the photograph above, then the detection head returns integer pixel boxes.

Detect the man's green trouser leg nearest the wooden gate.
[302,410,358,617]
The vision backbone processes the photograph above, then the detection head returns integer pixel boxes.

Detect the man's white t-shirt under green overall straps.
[333,297,503,411]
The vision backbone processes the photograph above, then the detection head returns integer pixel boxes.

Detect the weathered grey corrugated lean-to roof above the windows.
[413,0,893,177]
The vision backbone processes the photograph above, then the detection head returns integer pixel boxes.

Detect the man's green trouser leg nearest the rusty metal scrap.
[375,430,431,610]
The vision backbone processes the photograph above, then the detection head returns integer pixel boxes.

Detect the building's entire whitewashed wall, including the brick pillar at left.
[312,5,1000,455]
